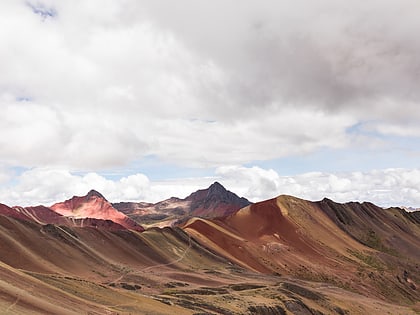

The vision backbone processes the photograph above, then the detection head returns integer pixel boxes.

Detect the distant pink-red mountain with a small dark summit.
[51,190,144,231]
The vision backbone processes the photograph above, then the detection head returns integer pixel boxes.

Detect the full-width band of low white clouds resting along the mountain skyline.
[0,166,420,207]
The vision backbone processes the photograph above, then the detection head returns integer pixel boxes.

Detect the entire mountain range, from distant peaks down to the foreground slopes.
[0,182,420,315]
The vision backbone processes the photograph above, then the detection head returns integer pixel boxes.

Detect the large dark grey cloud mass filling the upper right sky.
[139,0,420,110]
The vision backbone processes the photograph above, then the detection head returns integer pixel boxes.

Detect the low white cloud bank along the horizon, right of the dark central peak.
[216,166,420,207]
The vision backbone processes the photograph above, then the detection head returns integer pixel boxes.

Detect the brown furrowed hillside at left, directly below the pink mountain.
[0,215,230,281]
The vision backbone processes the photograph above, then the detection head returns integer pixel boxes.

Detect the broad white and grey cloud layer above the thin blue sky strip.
[0,0,420,170]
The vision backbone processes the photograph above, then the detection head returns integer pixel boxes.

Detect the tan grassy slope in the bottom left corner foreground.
[0,262,193,315]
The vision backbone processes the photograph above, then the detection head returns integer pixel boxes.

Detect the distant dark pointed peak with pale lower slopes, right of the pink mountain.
[112,182,251,226]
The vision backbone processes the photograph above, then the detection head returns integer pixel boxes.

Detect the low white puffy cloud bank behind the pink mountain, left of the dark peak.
[0,168,215,206]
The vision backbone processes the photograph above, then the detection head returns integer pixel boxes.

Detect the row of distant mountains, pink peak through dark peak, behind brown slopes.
[0,182,251,231]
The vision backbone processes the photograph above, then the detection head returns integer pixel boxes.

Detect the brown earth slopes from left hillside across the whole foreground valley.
[0,211,415,315]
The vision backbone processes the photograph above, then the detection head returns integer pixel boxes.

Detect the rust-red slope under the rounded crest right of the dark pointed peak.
[184,199,357,274]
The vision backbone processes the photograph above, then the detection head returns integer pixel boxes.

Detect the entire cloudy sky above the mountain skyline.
[0,0,420,207]
